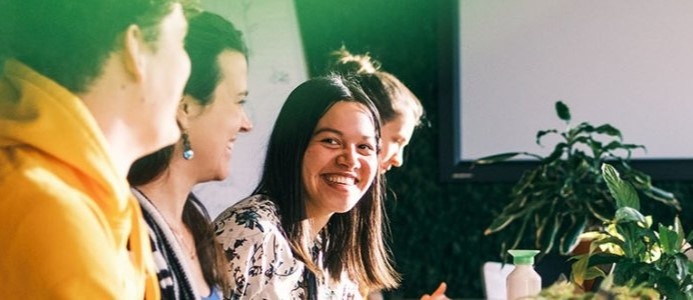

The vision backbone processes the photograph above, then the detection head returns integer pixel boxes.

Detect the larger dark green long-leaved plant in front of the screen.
[474,101,680,259]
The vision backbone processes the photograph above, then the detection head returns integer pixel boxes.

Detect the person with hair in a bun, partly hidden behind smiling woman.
[328,47,447,300]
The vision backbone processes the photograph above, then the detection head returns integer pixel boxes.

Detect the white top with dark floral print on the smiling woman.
[214,195,361,300]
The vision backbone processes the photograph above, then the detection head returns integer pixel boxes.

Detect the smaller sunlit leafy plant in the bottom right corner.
[572,164,693,299]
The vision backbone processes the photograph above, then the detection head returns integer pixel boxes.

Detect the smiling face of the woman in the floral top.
[302,101,378,218]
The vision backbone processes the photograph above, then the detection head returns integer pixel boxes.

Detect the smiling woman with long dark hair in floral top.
[215,76,399,299]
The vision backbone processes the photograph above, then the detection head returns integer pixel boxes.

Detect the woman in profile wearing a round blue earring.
[128,12,252,299]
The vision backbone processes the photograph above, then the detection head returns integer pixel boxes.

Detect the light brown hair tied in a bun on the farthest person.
[329,47,424,125]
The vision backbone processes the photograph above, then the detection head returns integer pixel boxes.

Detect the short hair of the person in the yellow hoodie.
[0,0,197,93]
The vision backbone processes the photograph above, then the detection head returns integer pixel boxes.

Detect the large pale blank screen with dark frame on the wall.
[441,0,693,179]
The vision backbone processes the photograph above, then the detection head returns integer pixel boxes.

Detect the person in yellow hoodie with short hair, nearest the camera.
[0,0,190,299]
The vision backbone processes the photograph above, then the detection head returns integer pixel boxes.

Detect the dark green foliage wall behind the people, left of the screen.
[295,0,693,298]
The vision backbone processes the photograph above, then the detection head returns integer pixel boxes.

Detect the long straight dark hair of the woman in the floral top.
[254,75,399,289]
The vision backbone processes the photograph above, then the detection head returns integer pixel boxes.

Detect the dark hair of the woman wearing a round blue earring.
[128,12,248,289]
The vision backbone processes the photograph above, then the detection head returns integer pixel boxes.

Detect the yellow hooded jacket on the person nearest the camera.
[0,61,159,299]
